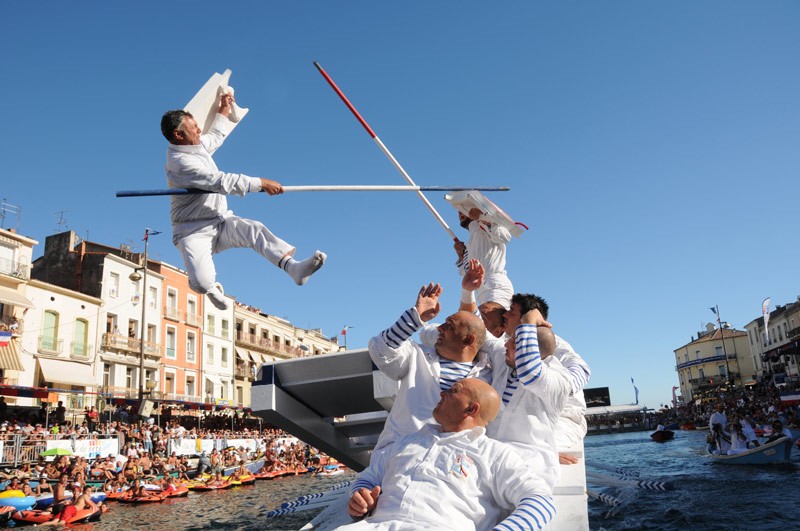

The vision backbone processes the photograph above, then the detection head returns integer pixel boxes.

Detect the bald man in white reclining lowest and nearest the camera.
[340,378,555,531]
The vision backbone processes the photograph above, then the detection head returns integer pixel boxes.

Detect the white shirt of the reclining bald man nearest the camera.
[344,425,555,531]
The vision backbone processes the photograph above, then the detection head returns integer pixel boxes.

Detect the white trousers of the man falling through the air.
[175,216,295,294]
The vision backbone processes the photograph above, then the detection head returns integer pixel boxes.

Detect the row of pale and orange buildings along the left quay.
[0,229,339,416]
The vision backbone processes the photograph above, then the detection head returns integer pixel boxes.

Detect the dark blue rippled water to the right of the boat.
[585,431,800,531]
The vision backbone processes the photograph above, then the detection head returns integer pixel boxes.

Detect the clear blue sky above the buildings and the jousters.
[0,0,800,407]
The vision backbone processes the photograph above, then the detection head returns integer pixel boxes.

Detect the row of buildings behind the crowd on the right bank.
[674,297,800,402]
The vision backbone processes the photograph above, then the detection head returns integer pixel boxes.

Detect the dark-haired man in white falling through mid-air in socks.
[161,94,327,310]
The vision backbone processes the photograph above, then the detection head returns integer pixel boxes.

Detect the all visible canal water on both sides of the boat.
[57,431,800,531]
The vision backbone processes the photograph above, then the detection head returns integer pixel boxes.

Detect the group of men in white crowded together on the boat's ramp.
[340,208,590,530]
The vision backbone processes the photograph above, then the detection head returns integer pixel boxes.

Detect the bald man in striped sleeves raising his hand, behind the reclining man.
[369,283,488,458]
